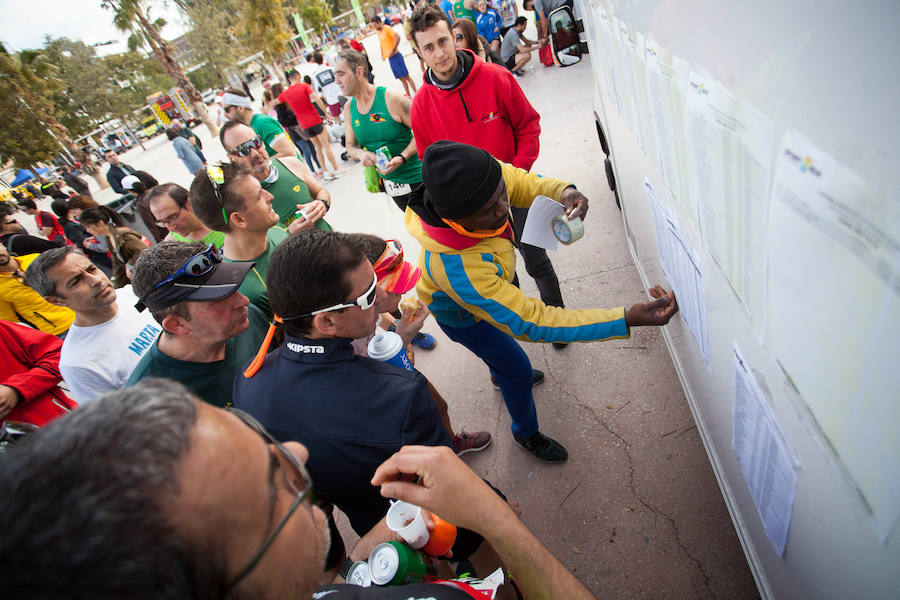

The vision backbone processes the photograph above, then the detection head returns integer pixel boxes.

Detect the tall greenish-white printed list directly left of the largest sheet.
[687,71,776,337]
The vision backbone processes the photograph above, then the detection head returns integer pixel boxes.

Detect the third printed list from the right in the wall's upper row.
[644,38,698,229]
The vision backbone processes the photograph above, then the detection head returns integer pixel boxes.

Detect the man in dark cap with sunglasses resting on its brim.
[127,242,268,406]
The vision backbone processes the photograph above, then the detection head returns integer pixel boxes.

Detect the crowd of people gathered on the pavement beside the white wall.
[0,0,678,599]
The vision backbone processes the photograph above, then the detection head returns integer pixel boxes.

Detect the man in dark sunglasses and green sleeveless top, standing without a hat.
[219,121,331,231]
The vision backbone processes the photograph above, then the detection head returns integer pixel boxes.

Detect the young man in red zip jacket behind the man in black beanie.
[409,4,566,348]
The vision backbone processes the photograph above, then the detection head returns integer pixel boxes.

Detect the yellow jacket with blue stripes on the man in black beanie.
[406,163,628,342]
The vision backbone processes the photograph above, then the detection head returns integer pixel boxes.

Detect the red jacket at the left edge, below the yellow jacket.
[0,323,62,402]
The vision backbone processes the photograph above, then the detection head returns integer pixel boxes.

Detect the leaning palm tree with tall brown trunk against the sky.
[100,0,219,135]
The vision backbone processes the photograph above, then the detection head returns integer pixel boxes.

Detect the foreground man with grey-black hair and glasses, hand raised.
[0,379,592,600]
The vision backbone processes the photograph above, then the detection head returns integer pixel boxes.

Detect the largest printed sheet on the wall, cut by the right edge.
[766,131,900,542]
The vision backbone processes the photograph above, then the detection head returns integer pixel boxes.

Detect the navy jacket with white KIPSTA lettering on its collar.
[234,335,452,535]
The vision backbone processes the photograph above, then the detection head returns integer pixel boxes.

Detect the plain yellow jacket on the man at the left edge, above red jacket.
[0,254,75,335]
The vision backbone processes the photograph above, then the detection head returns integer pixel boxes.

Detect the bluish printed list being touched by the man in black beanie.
[644,179,712,369]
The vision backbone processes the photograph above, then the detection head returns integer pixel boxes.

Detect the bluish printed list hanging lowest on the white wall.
[732,345,797,556]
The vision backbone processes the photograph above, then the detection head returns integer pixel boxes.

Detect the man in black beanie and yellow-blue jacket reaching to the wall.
[406,140,678,462]
